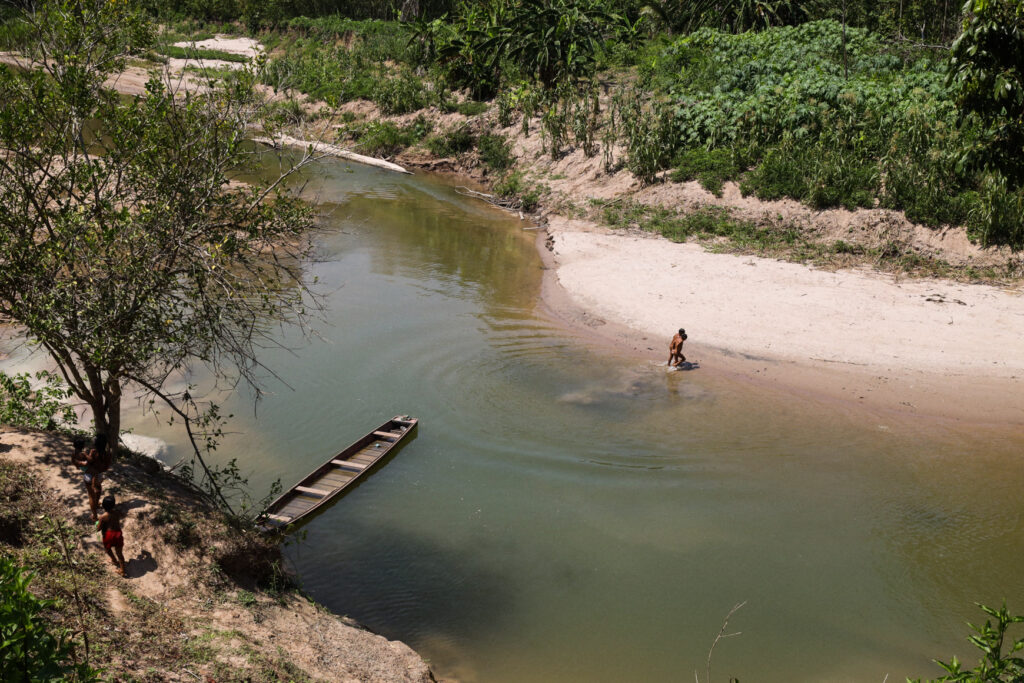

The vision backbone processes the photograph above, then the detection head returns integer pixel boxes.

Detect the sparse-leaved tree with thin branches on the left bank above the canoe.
[0,0,315,503]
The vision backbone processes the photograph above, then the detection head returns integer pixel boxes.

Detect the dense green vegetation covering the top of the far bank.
[209,0,1024,248]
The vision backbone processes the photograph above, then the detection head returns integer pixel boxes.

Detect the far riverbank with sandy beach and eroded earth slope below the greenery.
[12,25,1024,424]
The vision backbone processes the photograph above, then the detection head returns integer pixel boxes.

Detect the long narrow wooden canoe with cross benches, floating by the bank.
[257,415,419,531]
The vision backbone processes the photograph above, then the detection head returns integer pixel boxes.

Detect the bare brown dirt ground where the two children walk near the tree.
[0,428,434,683]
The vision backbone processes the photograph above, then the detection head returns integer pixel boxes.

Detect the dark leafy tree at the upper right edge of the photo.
[949,0,1024,186]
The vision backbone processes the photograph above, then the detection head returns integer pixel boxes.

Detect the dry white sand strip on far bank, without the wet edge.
[549,219,1024,378]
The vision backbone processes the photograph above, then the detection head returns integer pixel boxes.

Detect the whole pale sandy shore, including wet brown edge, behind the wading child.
[542,217,1024,425]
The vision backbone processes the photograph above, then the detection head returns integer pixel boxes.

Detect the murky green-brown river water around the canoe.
[4,157,1024,682]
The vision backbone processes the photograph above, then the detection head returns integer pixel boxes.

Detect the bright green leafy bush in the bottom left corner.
[0,557,99,682]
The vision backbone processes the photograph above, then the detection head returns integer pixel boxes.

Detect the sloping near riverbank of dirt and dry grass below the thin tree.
[0,427,434,683]
